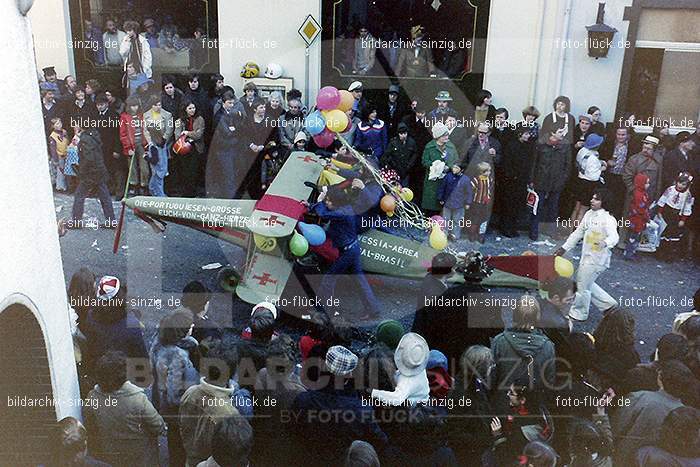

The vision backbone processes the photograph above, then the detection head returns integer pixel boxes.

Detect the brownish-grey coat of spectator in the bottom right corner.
[611,390,683,465]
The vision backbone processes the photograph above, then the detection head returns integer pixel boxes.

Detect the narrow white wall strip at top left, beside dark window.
[27,0,75,78]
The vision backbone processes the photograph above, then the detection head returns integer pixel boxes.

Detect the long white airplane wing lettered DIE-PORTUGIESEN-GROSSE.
[125,196,255,248]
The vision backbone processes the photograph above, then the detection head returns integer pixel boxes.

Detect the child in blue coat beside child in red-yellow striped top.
[438,164,472,240]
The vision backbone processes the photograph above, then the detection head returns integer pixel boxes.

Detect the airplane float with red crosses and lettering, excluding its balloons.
[115,148,576,314]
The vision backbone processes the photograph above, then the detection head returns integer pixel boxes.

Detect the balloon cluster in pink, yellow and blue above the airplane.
[304,86,355,148]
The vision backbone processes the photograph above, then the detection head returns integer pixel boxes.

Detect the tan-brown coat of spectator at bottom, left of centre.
[179,378,245,465]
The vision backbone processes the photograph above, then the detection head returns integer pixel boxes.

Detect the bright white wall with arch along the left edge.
[0,0,80,419]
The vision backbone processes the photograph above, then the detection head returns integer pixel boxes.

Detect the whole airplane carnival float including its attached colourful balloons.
[114,88,573,318]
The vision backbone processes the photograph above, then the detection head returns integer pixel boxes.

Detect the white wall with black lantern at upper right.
[484,0,632,121]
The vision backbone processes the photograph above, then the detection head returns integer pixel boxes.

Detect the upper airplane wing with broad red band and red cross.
[250,151,323,237]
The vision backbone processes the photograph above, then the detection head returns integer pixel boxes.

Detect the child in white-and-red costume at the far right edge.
[656,172,694,261]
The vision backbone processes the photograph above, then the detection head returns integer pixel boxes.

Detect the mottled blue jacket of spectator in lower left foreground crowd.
[150,337,199,415]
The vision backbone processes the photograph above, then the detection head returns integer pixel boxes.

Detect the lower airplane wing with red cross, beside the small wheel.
[236,249,292,304]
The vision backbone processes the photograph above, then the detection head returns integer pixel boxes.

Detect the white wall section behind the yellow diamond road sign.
[218,0,322,108]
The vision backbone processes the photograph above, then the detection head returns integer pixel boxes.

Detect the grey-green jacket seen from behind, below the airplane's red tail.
[491,328,556,389]
